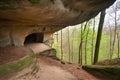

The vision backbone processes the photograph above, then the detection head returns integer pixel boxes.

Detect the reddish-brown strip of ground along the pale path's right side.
[39,56,111,80]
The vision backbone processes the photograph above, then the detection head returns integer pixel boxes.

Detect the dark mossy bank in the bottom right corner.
[82,66,120,80]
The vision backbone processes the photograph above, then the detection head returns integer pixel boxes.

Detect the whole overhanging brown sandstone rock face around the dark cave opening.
[0,0,115,47]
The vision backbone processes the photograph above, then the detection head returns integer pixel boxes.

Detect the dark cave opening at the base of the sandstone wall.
[24,33,44,44]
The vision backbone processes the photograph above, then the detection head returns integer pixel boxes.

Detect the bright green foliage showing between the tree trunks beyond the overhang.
[53,19,118,64]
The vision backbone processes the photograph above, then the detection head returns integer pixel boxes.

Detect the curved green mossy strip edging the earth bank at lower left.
[0,52,35,76]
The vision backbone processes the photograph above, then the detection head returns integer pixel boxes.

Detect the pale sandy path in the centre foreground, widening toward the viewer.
[9,58,78,80]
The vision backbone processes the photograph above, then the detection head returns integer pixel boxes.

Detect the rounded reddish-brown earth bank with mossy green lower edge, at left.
[0,46,35,80]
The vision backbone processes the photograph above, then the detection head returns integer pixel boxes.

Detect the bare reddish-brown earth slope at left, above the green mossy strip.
[0,47,29,65]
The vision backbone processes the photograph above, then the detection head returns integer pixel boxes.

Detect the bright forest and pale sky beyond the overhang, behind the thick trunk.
[51,0,120,64]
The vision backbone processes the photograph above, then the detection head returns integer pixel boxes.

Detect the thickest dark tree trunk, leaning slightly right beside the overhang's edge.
[93,10,105,64]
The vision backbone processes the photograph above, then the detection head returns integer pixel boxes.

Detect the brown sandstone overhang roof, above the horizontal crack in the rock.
[0,0,115,27]
